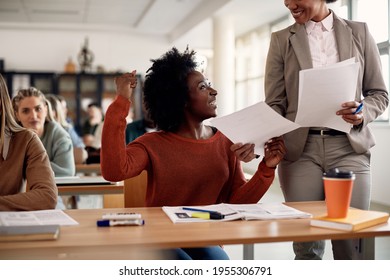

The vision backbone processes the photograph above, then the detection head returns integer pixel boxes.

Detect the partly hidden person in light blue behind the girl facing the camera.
[45,94,88,164]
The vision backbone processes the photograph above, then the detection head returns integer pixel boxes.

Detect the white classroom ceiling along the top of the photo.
[0,0,287,47]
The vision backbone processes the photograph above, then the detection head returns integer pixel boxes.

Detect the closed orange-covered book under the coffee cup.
[310,209,389,231]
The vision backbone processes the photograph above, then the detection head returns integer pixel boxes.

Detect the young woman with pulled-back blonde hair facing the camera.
[12,87,76,209]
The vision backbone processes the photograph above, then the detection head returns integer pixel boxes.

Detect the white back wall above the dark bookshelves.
[0,29,177,73]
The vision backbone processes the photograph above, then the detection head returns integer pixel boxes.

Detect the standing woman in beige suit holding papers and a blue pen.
[265,0,389,259]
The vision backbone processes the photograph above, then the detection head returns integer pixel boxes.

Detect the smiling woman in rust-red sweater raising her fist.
[101,48,285,259]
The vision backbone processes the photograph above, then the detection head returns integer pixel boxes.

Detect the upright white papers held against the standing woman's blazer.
[295,58,359,133]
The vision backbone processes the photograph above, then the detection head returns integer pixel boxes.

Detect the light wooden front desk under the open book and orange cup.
[0,202,390,259]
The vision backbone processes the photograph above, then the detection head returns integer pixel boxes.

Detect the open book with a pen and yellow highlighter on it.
[162,203,312,223]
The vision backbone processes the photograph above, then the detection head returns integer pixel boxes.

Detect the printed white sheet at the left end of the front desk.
[0,209,79,226]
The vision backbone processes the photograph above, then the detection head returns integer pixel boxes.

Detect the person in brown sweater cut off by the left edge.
[0,75,57,211]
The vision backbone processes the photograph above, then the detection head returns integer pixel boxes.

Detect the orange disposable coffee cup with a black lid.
[322,168,355,219]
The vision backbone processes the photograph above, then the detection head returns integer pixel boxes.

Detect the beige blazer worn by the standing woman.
[265,13,389,161]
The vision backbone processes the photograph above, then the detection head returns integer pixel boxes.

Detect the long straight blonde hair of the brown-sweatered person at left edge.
[0,74,24,151]
